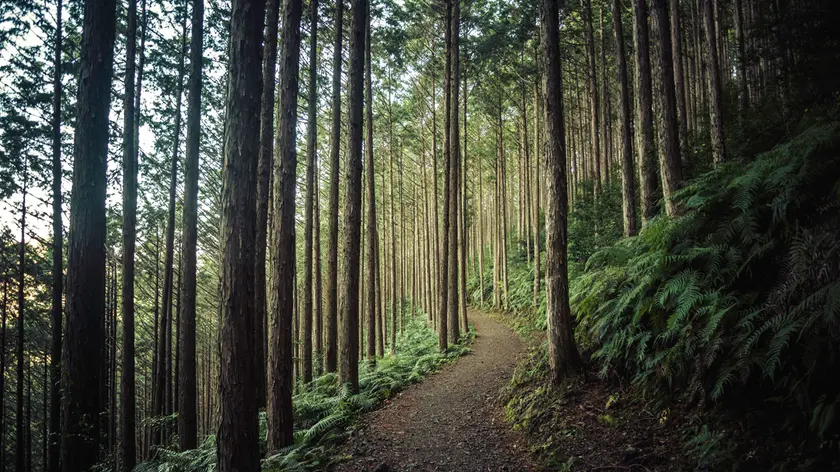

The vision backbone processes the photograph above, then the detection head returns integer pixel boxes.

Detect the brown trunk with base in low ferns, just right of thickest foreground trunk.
[267,0,302,452]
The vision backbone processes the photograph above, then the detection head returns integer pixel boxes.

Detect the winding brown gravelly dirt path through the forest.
[334,311,535,472]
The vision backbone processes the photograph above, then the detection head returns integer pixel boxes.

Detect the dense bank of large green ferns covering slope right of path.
[570,122,840,466]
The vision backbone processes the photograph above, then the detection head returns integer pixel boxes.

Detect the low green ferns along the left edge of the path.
[137,315,475,472]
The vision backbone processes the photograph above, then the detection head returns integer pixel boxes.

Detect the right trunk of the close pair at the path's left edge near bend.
[444,0,461,344]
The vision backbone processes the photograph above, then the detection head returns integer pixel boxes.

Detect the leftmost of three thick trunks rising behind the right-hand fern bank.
[612,0,640,236]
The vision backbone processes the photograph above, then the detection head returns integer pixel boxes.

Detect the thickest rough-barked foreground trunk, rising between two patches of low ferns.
[217,0,266,472]
